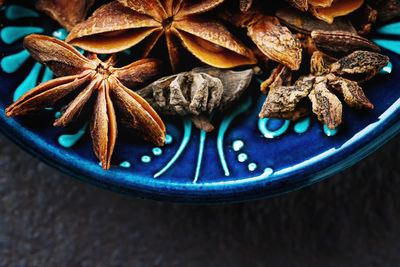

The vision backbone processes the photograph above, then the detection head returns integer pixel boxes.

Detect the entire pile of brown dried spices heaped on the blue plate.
[0,0,400,170]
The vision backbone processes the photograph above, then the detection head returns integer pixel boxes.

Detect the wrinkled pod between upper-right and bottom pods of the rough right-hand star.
[327,74,374,109]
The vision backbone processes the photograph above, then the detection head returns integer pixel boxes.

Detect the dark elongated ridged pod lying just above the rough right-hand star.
[311,31,381,58]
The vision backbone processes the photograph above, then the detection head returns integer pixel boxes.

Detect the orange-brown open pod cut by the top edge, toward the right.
[310,0,364,23]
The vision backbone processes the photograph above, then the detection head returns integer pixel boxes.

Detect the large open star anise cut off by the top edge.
[67,0,256,71]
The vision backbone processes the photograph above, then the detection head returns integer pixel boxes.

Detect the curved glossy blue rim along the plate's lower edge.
[0,98,400,204]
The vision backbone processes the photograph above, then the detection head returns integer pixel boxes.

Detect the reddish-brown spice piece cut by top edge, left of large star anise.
[36,0,95,31]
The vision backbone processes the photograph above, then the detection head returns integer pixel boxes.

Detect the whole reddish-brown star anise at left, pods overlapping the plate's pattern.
[6,35,166,170]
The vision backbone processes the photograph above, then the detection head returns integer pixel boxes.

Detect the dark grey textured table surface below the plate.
[0,132,400,266]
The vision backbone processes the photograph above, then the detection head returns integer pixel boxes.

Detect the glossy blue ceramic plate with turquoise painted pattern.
[0,6,400,203]
